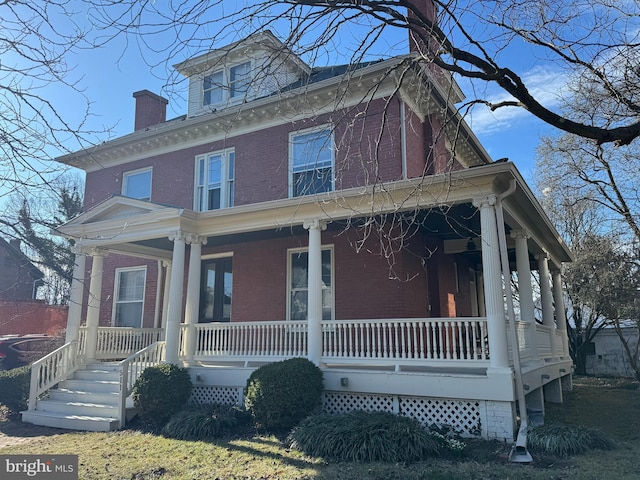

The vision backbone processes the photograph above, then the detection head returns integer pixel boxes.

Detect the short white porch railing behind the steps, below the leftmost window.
[79,327,163,360]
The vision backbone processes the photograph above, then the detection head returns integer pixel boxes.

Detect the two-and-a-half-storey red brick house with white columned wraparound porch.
[23,22,572,439]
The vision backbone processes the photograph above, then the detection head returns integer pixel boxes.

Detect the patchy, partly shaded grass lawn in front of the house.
[0,378,640,480]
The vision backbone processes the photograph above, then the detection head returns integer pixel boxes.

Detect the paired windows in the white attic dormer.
[202,62,251,106]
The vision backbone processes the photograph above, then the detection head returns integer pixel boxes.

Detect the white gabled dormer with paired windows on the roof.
[174,32,311,117]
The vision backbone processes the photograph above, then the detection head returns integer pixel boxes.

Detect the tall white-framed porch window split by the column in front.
[287,247,334,320]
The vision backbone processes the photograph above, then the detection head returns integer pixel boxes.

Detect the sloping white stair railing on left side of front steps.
[28,342,80,410]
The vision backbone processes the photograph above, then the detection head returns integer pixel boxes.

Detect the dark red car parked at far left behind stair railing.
[0,334,62,370]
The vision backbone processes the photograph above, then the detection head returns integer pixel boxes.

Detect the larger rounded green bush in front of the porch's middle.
[245,358,324,431]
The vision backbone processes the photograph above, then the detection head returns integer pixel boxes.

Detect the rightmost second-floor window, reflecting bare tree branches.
[289,126,334,197]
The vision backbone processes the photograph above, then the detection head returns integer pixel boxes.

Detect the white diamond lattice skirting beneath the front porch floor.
[191,386,484,437]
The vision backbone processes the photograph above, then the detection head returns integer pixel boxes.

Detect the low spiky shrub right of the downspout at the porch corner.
[527,424,614,457]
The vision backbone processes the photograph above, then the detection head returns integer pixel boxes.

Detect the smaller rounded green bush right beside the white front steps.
[132,363,192,428]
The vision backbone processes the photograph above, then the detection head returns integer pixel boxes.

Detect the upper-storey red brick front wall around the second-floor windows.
[85,100,402,210]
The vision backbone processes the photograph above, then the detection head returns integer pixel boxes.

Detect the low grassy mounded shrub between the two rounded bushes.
[162,404,250,440]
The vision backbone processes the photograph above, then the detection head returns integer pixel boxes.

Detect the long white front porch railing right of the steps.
[180,318,489,365]
